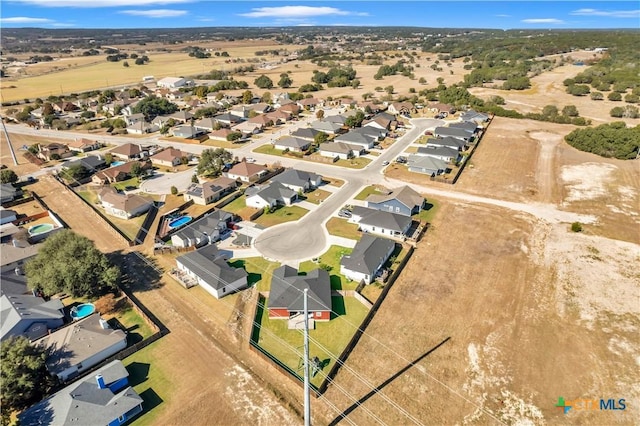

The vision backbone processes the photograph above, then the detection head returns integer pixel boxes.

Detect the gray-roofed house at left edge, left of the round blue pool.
[0,294,64,341]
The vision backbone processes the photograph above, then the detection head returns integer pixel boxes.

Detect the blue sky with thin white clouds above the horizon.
[0,0,640,30]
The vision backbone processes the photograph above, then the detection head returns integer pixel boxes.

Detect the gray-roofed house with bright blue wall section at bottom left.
[18,360,143,426]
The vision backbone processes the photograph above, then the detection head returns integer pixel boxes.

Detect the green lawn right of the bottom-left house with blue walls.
[122,340,170,426]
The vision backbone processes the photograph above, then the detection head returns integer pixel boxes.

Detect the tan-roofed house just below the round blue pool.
[33,312,127,382]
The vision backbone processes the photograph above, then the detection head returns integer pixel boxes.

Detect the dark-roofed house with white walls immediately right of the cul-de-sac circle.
[340,234,396,284]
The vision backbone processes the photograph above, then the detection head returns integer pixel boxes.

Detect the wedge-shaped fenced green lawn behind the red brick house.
[252,296,368,386]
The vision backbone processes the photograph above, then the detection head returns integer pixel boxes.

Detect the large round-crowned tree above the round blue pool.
[25,229,120,297]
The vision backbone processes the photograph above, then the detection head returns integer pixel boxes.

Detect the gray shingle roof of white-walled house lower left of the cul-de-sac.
[176,244,247,290]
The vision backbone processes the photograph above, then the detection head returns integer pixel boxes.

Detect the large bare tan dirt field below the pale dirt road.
[324,203,640,425]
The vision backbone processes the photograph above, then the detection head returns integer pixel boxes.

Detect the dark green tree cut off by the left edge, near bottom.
[0,336,52,411]
